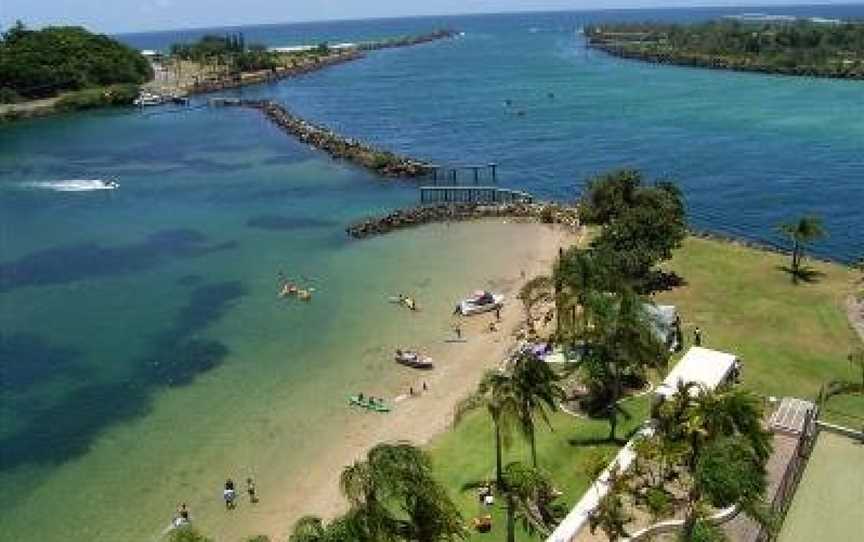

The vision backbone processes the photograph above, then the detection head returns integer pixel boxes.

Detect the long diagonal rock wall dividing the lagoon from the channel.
[230,100,432,177]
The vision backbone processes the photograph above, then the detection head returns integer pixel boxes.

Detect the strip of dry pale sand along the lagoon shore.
[238,223,577,540]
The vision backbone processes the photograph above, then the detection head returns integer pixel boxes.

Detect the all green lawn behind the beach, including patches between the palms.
[429,238,864,540]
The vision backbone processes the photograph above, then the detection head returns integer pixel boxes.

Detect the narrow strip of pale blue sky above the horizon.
[0,0,851,33]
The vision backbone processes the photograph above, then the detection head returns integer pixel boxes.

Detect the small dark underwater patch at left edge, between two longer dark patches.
[0,333,81,394]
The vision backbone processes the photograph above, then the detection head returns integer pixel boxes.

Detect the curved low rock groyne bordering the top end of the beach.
[345,203,580,239]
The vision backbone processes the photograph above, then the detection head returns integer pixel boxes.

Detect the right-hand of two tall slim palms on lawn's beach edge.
[508,351,564,468]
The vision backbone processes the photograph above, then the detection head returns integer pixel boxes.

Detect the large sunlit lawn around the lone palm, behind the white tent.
[656,238,864,408]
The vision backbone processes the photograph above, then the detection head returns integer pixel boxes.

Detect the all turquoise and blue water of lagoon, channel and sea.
[0,6,864,540]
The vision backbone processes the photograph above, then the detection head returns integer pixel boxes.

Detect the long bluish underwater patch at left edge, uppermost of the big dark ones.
[0,229,237,292]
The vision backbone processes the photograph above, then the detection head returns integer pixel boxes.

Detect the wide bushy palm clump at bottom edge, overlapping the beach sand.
[291,443,465,542]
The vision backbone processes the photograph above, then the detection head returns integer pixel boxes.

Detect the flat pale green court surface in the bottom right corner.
[779,431,864,542]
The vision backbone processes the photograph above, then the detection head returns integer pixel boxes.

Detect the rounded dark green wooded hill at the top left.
[0,23,153,103]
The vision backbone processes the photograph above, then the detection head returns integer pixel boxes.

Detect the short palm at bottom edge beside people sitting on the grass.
[501,461,566,542]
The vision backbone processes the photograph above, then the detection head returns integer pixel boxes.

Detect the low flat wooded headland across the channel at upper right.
[585,20,864,79]
